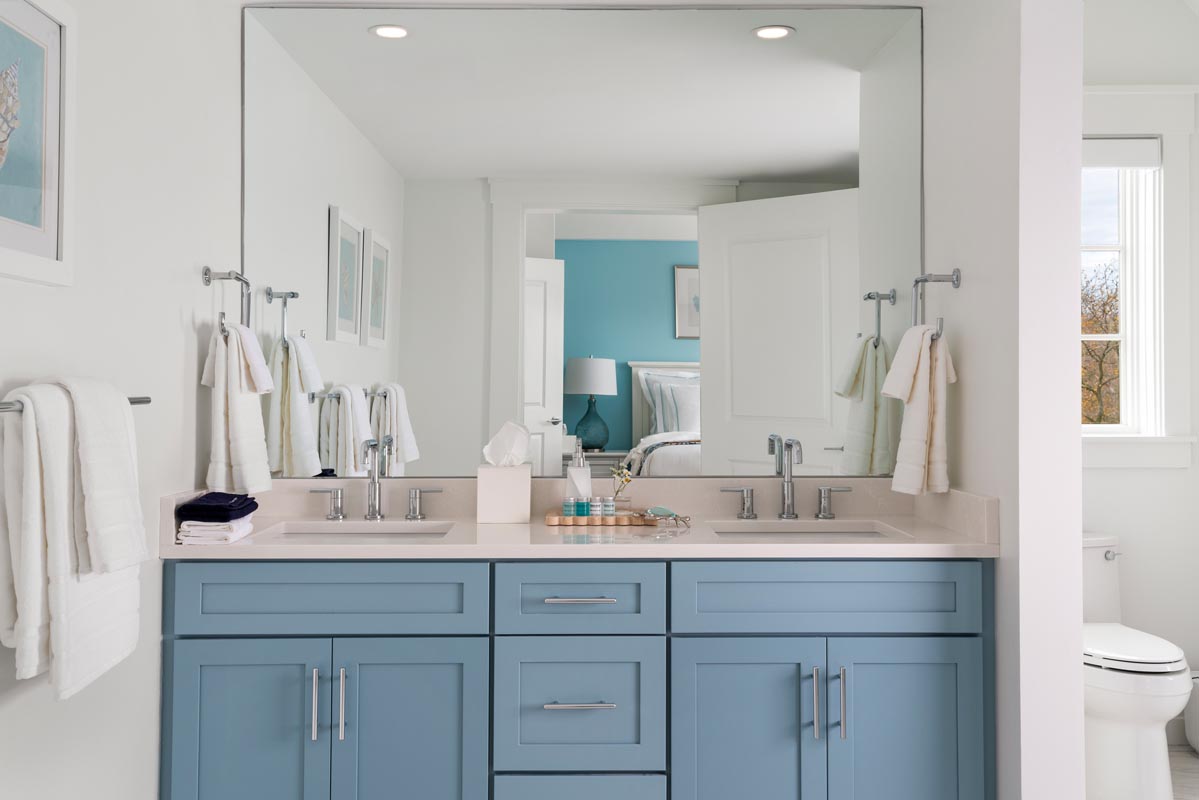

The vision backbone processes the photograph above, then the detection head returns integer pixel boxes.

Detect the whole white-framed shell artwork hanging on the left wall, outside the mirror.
[0,0,76,285]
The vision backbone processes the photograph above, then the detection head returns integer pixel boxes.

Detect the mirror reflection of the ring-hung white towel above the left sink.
[266,338,323,477]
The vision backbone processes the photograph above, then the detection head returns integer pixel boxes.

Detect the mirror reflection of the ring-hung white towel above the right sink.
[833,336,894,475]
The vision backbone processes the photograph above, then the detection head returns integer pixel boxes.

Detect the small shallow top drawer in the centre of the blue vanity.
[495,564,667,634]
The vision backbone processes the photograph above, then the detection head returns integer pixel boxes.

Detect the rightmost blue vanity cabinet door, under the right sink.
[829,637,984,800]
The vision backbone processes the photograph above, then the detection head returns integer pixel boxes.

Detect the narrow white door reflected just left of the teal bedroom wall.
[524,258,566,476]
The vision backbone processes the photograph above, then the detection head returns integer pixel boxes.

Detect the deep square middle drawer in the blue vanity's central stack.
[493,636,667,772]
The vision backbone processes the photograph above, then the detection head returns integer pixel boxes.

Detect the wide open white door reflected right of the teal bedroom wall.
[699,190,860,475]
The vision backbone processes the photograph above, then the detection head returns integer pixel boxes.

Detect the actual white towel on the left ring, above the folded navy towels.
[200,330,271,494]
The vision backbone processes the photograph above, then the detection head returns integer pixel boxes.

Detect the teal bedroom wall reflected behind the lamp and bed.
[555,239,699,450]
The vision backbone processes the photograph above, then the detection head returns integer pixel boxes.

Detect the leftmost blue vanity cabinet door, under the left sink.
[162,639,332,800]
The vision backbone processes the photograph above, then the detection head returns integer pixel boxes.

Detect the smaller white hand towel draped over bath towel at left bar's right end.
[58,378,150,572]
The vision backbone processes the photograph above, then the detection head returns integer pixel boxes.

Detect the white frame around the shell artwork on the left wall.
[0,0,79,287]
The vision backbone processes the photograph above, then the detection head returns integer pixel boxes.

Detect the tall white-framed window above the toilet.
[1080,139,1162,435]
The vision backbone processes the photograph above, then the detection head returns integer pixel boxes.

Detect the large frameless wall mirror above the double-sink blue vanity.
[245,8,922,476]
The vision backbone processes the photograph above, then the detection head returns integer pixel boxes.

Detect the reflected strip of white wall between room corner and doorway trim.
[399,181,494,475]
